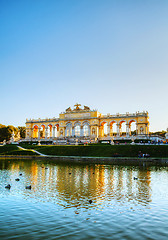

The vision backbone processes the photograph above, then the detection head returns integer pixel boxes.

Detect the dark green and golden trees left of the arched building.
[0,124,26,142]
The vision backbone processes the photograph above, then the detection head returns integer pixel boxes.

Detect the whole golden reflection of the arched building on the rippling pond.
[1,160,151,207]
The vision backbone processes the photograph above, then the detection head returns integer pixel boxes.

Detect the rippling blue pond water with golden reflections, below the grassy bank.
[0,160,168,240]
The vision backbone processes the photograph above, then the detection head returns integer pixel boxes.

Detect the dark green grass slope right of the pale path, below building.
[19,144,168,158]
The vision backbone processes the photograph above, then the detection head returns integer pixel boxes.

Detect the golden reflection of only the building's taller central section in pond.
[57,165,104,206]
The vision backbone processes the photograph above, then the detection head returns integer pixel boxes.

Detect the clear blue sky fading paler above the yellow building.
[0,0,168,131]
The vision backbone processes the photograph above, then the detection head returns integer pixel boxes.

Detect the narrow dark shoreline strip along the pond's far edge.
[0,155,168,166]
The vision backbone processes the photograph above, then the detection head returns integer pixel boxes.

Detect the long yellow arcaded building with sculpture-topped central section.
[26,104,149,140]
